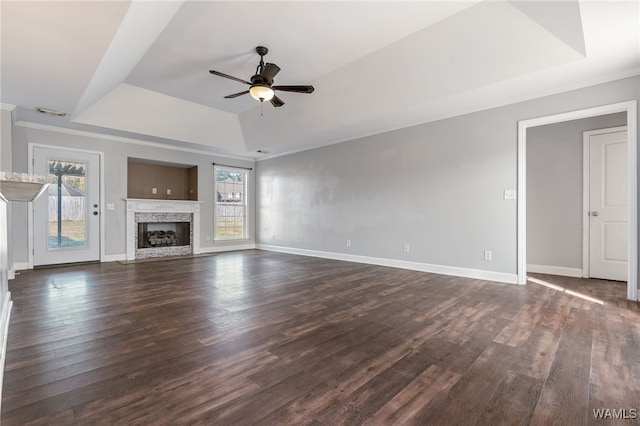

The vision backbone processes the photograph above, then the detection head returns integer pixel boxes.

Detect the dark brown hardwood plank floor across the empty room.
[2,251,640,426]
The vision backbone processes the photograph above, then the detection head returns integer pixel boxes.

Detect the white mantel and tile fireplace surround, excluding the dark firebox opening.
[125,198,200,260]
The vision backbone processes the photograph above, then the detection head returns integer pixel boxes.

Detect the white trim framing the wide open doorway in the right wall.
[516,100,639,301]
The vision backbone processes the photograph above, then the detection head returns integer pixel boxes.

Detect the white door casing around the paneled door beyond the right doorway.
[582,126,629,278]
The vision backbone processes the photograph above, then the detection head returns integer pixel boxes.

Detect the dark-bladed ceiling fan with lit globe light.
[209,46,315,107]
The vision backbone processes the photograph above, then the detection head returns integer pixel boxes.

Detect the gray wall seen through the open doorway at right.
[527,113,627,269]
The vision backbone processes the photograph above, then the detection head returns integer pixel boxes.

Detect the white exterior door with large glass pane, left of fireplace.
[33,147,100,266]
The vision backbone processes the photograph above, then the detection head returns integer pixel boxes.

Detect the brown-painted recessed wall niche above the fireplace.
[127,158,198,201]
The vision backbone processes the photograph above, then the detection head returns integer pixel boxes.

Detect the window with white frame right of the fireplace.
[214,166,247,240]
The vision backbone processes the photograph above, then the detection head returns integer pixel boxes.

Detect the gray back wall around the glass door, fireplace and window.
[13,125,255,263]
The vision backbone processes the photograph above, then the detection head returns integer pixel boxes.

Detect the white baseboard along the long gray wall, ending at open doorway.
[256,244,518,284]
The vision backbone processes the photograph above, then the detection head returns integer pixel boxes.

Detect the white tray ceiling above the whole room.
[0,0,640,157]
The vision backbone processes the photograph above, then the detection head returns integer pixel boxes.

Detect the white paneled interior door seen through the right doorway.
[588,130,629,281]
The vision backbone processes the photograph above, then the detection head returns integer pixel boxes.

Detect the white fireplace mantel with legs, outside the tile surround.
[125,198,201,260]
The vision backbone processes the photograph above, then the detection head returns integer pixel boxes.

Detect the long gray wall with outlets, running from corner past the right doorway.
[256,77,640,274]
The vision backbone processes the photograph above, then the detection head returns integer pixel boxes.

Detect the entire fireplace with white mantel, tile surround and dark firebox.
[126,199,200,260]
